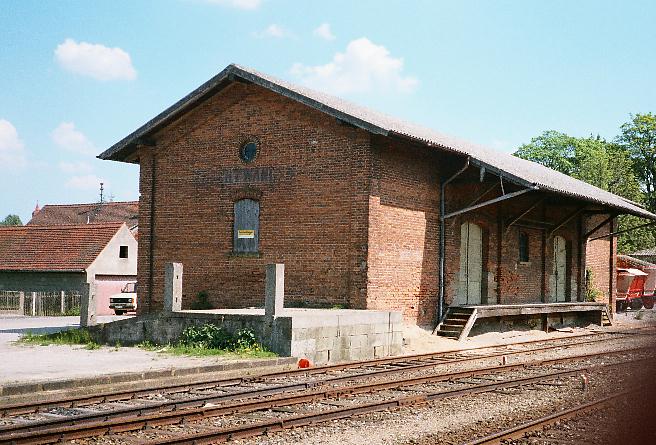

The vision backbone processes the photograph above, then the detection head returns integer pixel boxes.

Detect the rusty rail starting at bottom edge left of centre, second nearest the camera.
[139,360,652,445]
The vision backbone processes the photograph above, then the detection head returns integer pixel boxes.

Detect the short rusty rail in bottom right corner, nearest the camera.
[464,388,644,445]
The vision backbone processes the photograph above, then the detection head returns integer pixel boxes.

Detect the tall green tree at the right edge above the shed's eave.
[617,113,656,212]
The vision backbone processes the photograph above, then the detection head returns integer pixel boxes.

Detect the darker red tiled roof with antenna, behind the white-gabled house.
[27,201,139,228]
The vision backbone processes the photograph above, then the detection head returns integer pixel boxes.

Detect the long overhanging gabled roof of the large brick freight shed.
[98,64,656,220]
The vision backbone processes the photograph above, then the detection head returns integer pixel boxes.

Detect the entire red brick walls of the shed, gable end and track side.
[138,83,600,325]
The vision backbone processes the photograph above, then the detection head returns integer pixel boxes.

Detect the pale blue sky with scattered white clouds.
[0,0,656,222]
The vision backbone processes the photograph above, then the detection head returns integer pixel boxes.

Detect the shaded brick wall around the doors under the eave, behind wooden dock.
[446,186,580,304]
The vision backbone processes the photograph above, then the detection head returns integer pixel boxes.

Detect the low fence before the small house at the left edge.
[0,291,81,317]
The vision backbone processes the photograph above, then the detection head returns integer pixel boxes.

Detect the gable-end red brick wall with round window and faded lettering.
[138,84,370,308]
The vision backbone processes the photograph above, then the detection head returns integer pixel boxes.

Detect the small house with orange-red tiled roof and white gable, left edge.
[0,222,137,315]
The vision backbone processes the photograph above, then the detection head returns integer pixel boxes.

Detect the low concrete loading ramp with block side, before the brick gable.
[96,308,403,364]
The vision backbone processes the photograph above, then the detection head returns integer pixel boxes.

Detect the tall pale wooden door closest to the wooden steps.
[456,223,483,304]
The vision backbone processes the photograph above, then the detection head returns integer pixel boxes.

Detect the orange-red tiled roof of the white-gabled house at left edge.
[0,222,125,272]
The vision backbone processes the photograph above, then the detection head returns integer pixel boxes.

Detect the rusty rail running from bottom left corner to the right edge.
[0,348,656,443]
